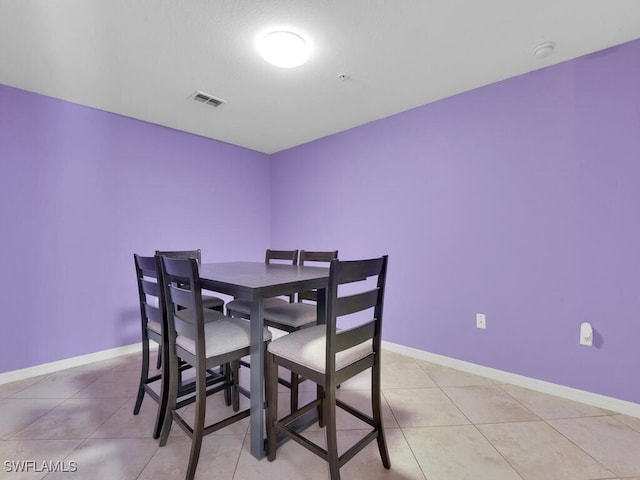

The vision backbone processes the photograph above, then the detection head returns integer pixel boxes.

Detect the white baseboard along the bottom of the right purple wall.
[382,341,640,418]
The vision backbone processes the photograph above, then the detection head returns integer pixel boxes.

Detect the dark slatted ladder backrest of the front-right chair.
[326,255,388,383]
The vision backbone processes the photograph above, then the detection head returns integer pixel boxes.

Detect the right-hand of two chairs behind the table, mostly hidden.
[264,250,338,411]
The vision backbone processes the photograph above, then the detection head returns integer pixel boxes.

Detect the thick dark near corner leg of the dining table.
[250,298,266,459]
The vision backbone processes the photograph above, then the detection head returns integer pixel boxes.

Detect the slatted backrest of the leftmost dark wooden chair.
[133,254,167,335]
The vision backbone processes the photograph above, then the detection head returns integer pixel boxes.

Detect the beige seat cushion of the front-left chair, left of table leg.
[176,317,271,358]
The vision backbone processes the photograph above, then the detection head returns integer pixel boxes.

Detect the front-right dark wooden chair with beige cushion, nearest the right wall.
[266,255,391,480]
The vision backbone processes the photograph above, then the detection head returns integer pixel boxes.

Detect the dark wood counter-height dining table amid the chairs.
[200,262,329,458]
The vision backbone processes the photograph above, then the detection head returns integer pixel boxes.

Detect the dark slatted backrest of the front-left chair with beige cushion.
[159,256,205,355]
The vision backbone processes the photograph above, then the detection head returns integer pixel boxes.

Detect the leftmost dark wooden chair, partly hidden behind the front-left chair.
[133,254,232,438]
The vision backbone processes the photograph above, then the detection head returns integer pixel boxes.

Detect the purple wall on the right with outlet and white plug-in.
[271,41,640,402]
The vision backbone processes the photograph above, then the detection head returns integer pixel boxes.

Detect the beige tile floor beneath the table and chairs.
[0,352,640,480]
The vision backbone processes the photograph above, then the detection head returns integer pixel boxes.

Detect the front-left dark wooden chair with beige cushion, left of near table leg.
[160,256,271,480]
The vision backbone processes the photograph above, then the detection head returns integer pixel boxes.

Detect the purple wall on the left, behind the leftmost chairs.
[0,86,270,372]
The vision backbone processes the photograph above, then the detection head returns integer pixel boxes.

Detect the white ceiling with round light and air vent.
[0,0,640,153]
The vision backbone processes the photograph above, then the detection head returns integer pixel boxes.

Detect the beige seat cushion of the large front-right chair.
[268,325,373,373]
